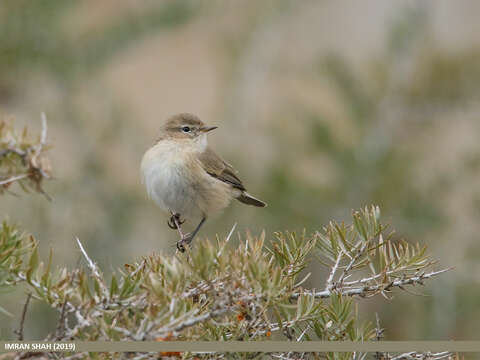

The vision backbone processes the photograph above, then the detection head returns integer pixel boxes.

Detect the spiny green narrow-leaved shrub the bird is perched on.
[0,202,448,359]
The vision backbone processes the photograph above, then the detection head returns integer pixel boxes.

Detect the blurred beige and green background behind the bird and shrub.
[0,0,480,340]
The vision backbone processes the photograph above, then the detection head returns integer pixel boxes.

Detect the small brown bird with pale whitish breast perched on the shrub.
[141,113,266,252]
